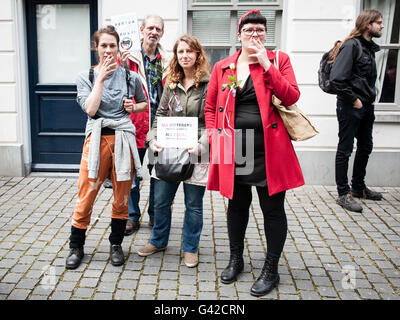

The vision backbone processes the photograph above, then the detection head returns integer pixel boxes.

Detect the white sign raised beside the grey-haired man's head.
[111,13,140,52]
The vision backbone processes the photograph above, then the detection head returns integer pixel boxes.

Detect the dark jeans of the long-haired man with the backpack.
[335,99,375,196]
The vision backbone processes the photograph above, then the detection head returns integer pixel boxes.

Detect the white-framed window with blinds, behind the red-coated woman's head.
[187,0,283,65]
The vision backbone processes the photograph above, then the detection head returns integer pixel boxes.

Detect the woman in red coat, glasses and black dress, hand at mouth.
[205,10,304,296]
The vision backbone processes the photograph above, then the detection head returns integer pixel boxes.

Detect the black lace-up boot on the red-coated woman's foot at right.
[250,256,279,297]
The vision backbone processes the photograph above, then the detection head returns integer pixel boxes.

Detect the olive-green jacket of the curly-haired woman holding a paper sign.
[145,76,210,147]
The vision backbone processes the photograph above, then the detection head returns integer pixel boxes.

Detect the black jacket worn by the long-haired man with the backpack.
[329,36,380,104]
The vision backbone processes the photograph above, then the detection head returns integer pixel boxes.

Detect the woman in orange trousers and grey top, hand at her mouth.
[66,26,147,269]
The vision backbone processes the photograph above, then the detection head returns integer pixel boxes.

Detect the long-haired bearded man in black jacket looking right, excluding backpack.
[329,9,384,212]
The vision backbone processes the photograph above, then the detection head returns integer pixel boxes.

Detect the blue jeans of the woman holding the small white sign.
[150,180,206,253]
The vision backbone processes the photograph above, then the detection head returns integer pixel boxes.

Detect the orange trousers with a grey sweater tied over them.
[72,135,135,229]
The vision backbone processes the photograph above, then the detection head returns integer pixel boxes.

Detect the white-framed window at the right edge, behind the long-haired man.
[363,0,400,111]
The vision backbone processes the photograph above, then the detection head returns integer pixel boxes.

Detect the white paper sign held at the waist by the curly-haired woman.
[157,117,198,148]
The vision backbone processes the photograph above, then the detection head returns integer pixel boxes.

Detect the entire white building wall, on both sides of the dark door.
[0,0,400,186]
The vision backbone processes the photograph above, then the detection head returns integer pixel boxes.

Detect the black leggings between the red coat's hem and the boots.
[227,183,287,258]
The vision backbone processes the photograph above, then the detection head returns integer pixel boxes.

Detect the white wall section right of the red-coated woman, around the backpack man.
[282,0,400,186]
